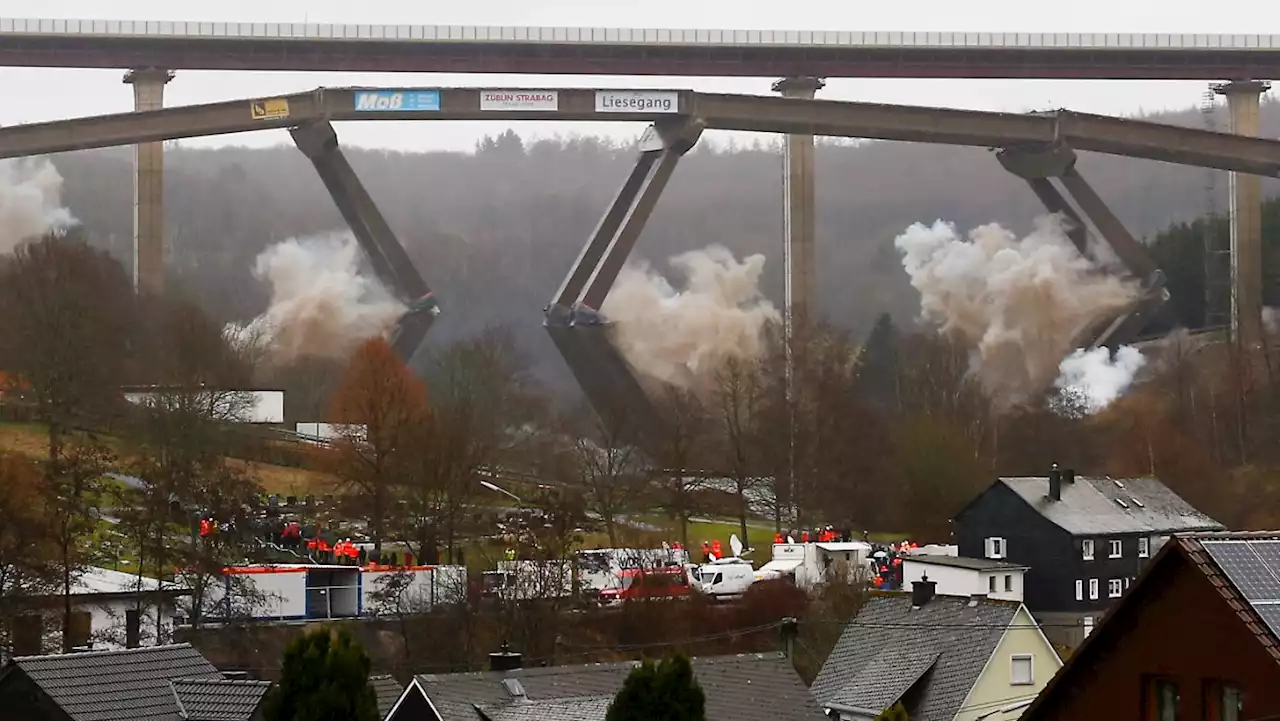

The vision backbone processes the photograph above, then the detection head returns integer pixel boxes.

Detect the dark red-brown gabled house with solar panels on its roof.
[1024,531,1280,721]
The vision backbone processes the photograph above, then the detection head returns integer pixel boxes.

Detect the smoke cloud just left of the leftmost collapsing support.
[228,233,406,362]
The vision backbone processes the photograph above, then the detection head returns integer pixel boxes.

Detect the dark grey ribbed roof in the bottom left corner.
[12,643,223,721]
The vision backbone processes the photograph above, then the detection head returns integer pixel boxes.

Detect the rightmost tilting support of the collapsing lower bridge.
[996,145,1169,351]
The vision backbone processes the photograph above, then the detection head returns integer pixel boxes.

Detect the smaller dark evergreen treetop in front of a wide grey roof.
[605,656,707,721]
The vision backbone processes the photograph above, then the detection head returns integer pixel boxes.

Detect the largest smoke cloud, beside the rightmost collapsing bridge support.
[895,215,1138,409]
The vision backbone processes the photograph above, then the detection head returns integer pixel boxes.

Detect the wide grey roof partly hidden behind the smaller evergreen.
[417,653,826,721]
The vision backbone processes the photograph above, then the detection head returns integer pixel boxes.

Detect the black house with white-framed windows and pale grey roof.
[954,466,1224,647]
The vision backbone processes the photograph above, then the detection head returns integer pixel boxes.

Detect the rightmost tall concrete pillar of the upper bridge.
[1213,81,1271,348]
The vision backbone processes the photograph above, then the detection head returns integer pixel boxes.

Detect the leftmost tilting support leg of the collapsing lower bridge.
[289,120,440,362]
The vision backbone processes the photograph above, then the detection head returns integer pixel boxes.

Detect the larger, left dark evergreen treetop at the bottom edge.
[262,628,379,721]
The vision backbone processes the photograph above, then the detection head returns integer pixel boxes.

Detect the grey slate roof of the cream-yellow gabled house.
[810,594,1020,721]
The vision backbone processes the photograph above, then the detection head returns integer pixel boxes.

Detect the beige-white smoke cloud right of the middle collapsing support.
[600,246,782,389]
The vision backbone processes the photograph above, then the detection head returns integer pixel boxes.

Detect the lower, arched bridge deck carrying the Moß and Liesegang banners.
[0,88,1280,177]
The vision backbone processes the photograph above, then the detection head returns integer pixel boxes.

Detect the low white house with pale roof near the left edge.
[3,567,188,656]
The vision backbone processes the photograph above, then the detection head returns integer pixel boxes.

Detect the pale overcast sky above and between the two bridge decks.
[0,0,1280,150]
